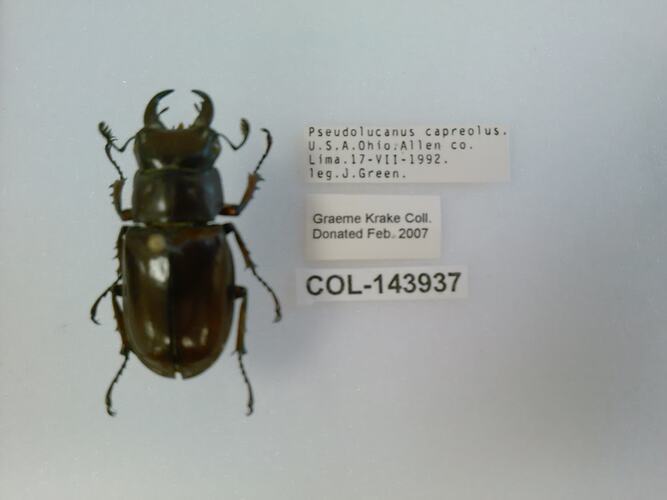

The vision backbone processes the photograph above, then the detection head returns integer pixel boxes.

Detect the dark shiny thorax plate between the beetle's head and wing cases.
[132,168,224,224]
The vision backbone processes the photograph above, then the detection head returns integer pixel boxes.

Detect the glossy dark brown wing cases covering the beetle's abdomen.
[121,226,235,378]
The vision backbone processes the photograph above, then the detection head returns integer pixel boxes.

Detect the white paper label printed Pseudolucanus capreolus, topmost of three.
[305,124,510,183]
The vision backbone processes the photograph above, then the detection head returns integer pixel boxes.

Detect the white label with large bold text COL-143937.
[296,266,468,304]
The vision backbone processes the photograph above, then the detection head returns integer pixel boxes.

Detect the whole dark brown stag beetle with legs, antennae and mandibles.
[90,90,281,416]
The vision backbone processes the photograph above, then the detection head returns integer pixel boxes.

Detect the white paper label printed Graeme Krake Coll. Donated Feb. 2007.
[306,194,440,260]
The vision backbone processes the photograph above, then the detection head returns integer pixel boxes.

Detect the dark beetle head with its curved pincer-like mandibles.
[134,90,220,169]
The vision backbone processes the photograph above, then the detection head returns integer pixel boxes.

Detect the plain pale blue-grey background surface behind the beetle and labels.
[0,0,667,500]
